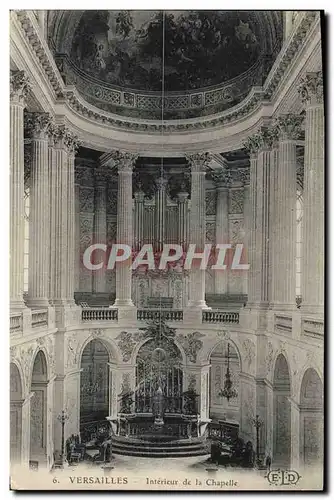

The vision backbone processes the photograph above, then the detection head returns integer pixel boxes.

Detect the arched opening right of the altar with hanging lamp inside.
[209,341,240,424]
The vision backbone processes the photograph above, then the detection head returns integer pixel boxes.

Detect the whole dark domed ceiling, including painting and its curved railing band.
[48,10,283,120]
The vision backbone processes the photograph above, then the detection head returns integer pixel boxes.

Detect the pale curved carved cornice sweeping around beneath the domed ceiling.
[11,10,318,151]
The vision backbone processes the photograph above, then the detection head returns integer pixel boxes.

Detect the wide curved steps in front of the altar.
[112,436,209,458]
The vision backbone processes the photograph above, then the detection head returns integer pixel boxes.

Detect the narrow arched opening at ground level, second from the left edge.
[30,351,48,463]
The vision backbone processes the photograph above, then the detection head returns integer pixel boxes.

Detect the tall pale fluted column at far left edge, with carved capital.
[10,71,30,309]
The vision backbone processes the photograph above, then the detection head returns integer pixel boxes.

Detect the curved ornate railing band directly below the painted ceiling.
[56,54,263,119]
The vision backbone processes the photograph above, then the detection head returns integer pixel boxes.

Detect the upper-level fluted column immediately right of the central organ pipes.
[188,153,210,309]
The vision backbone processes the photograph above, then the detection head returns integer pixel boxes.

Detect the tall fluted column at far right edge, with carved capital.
[299,72,325,314]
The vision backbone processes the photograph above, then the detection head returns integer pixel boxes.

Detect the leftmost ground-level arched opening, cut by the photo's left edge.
[10,363,22,464]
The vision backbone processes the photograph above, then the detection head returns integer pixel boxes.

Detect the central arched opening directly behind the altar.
[135,337,183,413]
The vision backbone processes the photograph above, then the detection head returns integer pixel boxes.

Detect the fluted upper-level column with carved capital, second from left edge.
[25,112,51,308]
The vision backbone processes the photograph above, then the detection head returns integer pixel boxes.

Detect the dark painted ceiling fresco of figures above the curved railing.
[70,11,261,91]
